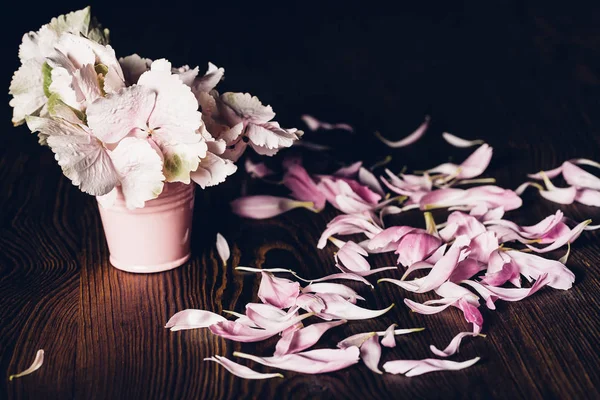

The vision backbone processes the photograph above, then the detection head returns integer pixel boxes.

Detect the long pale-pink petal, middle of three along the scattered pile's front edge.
[233,347,360,374]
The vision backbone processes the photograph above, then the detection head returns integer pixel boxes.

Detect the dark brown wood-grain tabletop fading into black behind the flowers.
[0,1,600,399]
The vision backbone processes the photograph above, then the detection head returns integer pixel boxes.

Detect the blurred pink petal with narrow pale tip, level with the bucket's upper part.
[231,196,314,219]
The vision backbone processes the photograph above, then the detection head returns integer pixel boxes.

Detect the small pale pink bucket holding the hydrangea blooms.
[98,183,195,273]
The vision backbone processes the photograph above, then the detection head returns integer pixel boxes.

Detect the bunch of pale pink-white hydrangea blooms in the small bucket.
[10,7,302,208]
